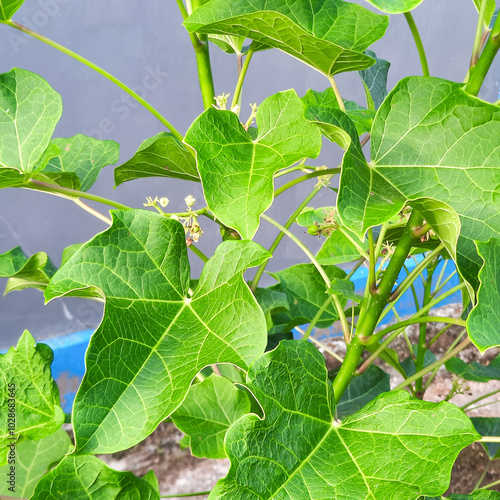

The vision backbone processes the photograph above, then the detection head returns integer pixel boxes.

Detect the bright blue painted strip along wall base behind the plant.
[3,256,461,413]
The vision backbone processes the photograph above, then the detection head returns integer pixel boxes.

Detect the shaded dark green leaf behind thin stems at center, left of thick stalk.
[269,264,346,333]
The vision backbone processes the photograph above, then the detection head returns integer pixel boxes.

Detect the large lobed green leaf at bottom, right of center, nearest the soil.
[209,340,480,500]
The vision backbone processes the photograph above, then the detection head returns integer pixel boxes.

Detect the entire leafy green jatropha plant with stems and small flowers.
[0,0,500,500]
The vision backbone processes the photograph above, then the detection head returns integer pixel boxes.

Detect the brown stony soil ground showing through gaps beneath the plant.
[94,306,500,500]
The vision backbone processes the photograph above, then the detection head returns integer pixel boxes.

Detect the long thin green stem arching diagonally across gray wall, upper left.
[5,20,184,142]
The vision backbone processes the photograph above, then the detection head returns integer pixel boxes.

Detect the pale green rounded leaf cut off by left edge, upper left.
[0,68,62,172]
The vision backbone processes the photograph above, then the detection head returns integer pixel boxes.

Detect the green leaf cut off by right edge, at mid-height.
[467,239,500,352]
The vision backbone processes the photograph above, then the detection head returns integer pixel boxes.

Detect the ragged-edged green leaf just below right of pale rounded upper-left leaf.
[37,134,120,191]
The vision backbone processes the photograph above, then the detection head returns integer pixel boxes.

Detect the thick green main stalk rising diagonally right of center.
[333,210,423,401]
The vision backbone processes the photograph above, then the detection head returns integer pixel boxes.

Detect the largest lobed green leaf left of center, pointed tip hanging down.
[45,210,270,453]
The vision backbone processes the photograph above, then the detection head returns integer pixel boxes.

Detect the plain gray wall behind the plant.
[0,0,500,348]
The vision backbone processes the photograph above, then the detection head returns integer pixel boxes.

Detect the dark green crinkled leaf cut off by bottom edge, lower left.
[31,455,160,500]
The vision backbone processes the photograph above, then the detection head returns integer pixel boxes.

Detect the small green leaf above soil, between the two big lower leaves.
[171,375,251,458]
